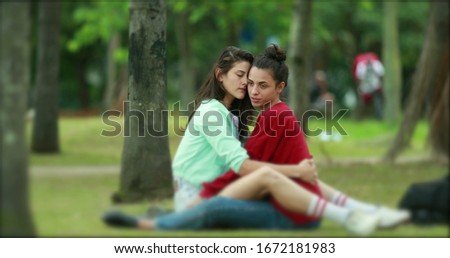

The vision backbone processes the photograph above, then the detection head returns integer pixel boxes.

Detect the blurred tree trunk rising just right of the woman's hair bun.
[287,0,312,132]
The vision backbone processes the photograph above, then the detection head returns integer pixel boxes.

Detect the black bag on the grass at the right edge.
[399,175,450,224]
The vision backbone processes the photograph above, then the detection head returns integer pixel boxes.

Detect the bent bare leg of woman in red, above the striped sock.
[219,167,313,214]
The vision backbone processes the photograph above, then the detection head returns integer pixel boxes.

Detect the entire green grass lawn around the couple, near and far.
[31,117,448,237]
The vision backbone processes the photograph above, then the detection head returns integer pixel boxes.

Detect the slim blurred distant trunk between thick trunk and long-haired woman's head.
[176,10,195,111]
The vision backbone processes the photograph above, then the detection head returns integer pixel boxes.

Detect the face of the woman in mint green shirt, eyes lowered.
[218,61,251,105]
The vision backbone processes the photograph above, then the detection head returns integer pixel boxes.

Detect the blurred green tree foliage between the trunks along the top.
[50,0,428,107]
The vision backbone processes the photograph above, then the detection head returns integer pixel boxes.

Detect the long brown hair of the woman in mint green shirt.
[188,46,254,140]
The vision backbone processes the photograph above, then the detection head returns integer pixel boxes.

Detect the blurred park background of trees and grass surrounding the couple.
[0,0,449,237]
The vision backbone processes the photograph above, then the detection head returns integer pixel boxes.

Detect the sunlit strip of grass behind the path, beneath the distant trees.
[28,117,429,165]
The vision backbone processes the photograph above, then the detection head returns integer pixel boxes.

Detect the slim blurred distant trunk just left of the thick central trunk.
[102,33,120,111]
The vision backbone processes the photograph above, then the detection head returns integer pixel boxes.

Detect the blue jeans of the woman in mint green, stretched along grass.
[155,196,320,230]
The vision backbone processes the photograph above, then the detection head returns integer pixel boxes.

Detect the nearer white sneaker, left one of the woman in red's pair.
[344,210,380,236]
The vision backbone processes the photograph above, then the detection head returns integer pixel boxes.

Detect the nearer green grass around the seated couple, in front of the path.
[31,163,448,237]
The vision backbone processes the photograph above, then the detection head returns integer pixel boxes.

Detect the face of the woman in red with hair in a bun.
[247,67,285,110]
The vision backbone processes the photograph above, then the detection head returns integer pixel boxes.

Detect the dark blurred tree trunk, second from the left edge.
[31,1,61,153]
